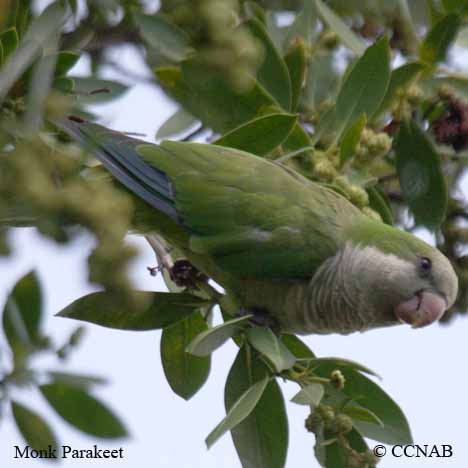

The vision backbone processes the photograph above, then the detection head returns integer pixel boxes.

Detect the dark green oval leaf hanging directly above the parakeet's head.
[394,121,448,229]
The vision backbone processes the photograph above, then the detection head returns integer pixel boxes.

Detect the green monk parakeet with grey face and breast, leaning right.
[57,117,458,334]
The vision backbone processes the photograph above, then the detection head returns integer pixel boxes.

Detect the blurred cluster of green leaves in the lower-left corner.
[0,271,127,450]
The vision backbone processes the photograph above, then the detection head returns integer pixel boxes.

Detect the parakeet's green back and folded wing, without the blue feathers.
[137,142,362,279]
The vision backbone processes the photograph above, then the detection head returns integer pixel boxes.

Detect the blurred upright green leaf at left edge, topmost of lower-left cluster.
[3,271,42,354]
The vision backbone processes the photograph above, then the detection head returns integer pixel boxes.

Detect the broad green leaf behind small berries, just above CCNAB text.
[314,363,412,445]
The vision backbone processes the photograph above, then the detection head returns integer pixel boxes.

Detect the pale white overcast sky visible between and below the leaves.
[0,4,468,468]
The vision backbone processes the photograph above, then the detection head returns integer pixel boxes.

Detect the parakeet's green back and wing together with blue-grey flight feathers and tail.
[58,121,363,279]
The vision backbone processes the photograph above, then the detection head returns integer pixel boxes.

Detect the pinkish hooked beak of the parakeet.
[395,290,447,328]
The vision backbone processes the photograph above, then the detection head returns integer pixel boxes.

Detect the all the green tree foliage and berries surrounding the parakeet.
[0,0,468,468]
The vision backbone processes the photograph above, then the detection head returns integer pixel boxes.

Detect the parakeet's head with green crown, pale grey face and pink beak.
[355,222,458,328]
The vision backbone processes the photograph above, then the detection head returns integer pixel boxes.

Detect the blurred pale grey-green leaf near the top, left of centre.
[135,14,191,62]
